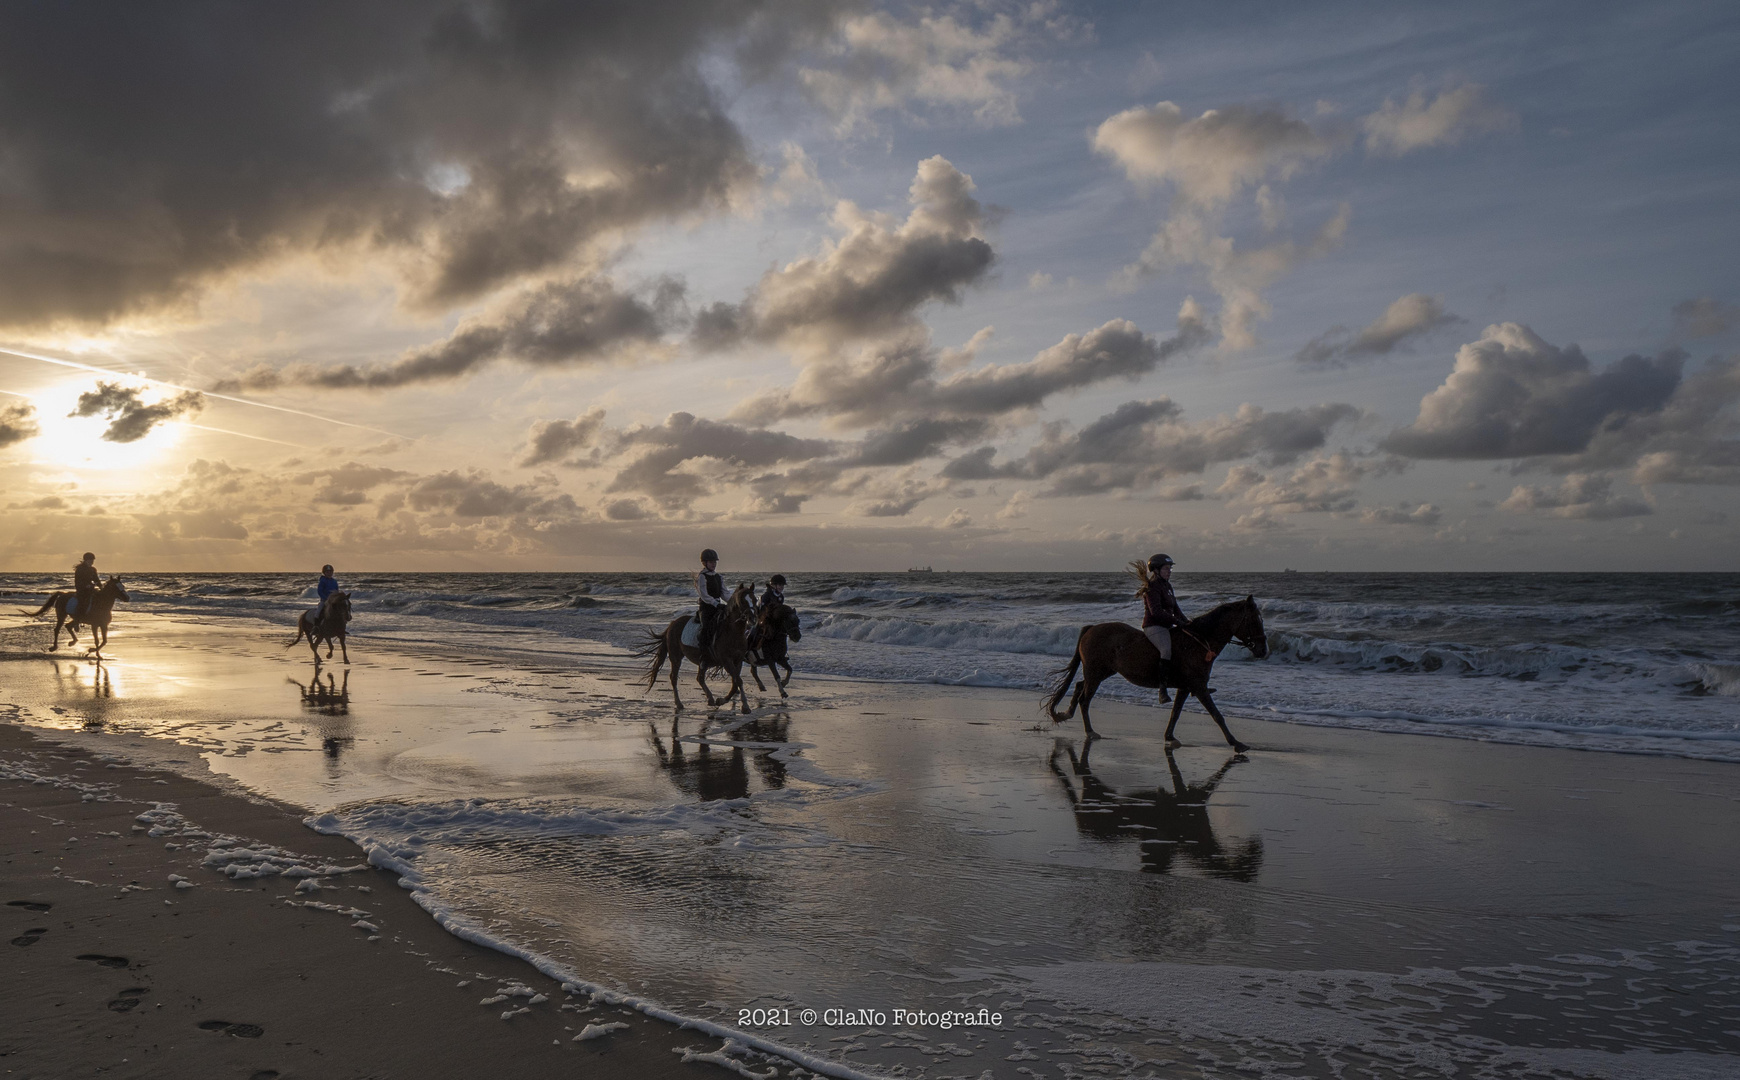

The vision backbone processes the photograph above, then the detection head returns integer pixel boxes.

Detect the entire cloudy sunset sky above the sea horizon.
[0,0,1740,576]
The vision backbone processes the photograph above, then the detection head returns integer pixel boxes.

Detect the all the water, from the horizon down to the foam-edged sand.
[0,570,1740,1080]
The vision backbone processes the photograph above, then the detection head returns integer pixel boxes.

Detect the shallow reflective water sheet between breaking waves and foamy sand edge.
[0,600,1740,1080]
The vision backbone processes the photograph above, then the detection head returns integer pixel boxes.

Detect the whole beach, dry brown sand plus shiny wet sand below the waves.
[0,605,1740,1078]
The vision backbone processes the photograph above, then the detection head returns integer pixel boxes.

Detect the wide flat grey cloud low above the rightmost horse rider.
[941,398,1362,496]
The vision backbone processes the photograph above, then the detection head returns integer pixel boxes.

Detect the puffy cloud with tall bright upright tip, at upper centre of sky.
[693,157,994,353]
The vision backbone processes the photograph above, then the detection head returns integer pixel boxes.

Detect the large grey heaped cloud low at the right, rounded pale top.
[1380,322,1684,459]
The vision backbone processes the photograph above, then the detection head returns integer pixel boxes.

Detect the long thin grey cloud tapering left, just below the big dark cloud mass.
[212,278,682,393]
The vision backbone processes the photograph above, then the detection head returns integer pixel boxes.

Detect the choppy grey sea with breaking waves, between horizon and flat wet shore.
[16,572,1740,762]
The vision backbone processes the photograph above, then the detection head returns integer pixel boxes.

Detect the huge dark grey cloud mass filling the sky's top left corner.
[0,0,837,327]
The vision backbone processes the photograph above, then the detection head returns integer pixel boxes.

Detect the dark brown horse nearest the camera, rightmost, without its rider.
[1046,597,1268,753]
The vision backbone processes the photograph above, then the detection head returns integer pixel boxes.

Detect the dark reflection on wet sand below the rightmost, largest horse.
[1047,739,1263,882]
